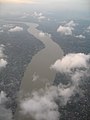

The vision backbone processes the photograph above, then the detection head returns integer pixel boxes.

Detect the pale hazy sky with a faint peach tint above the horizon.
[0,0,90,19]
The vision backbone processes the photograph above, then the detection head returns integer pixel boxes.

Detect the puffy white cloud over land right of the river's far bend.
[57,20,76,35]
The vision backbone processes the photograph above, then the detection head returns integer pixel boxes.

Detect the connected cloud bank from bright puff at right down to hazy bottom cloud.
[20,53,90,120]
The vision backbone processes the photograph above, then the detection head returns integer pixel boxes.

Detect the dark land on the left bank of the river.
[0,22,44,114]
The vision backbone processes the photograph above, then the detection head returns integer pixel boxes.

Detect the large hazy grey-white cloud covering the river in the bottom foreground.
[20,77,82,120]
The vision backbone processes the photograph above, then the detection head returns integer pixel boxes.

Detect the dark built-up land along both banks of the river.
[0,20,90,120]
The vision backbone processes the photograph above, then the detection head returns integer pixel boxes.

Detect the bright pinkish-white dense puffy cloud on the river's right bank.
[51,53,90,73]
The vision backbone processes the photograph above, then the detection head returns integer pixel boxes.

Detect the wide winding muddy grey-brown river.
[15,23,64,120]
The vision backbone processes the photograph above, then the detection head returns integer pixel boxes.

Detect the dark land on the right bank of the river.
[38,20,90,120]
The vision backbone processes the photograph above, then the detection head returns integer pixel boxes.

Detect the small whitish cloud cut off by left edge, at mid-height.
[0,44,7,68]
